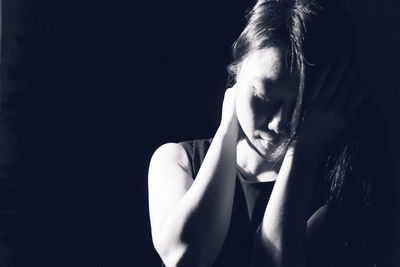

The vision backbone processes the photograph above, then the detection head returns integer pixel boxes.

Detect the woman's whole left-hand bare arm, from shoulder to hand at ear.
[149,90,238,266]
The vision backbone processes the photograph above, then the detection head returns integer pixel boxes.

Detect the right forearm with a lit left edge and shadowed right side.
[252,148,318,266]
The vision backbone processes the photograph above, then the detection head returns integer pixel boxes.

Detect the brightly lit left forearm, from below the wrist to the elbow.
[159,127,237,266]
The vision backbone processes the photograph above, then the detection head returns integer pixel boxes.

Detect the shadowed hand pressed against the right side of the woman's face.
[296,58,363,157]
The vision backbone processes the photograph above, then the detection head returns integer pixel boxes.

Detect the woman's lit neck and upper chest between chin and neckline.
[236,139,282,182]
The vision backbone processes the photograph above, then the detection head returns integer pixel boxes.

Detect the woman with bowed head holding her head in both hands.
[149,0,394,266]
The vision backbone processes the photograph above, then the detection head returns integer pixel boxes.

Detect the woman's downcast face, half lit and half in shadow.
[236,47,299,161]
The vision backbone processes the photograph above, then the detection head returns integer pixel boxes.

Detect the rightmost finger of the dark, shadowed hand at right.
[332,62,358,107]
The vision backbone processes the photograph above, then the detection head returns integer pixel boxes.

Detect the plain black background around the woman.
[0,0,400,266]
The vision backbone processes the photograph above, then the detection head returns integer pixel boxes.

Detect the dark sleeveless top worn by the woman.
[180,139,275,267]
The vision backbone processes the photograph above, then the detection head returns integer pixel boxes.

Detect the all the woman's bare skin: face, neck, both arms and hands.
[149,47,361,266]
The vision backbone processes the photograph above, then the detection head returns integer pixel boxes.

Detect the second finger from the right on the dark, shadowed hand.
[318,58,349,105]
